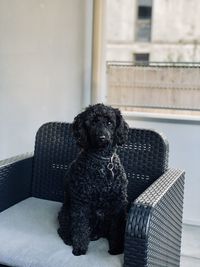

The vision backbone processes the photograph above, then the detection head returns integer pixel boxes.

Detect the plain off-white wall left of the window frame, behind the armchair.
[0,0,92,159]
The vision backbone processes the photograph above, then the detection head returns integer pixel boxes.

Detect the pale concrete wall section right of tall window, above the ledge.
[152,0,200,43]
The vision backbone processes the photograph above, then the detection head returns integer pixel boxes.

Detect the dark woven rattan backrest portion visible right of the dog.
[118,129,169,201]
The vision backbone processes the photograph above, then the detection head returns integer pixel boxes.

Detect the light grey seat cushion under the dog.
[0,198,123,267]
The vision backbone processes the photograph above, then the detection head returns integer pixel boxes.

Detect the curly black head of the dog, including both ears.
[73,104,128,149]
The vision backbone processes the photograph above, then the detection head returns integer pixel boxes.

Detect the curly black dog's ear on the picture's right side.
[114,109,129,146]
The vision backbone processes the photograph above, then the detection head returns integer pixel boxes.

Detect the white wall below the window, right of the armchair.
[127,115,200,225]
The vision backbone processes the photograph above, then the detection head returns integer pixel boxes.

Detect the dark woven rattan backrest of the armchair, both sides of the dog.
[32,122,168,201]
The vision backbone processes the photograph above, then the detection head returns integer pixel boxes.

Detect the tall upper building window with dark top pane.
[136,0,152,42]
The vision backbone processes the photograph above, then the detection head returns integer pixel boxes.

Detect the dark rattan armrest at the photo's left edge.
[0,153,33,212]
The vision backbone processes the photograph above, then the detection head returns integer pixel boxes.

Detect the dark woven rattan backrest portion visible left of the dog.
[32,122,78,201]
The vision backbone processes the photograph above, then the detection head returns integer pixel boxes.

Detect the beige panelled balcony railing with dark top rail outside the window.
[107,62,200,111]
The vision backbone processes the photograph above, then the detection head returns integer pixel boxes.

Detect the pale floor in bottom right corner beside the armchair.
[181,224,200,267]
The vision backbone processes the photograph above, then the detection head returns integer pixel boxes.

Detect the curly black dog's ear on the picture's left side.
[72,111,88,148]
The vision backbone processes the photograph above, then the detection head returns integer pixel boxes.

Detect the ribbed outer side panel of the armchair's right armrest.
[147,175,184,267]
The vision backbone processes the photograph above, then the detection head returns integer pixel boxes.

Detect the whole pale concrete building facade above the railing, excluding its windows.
[107,0,200,62]
